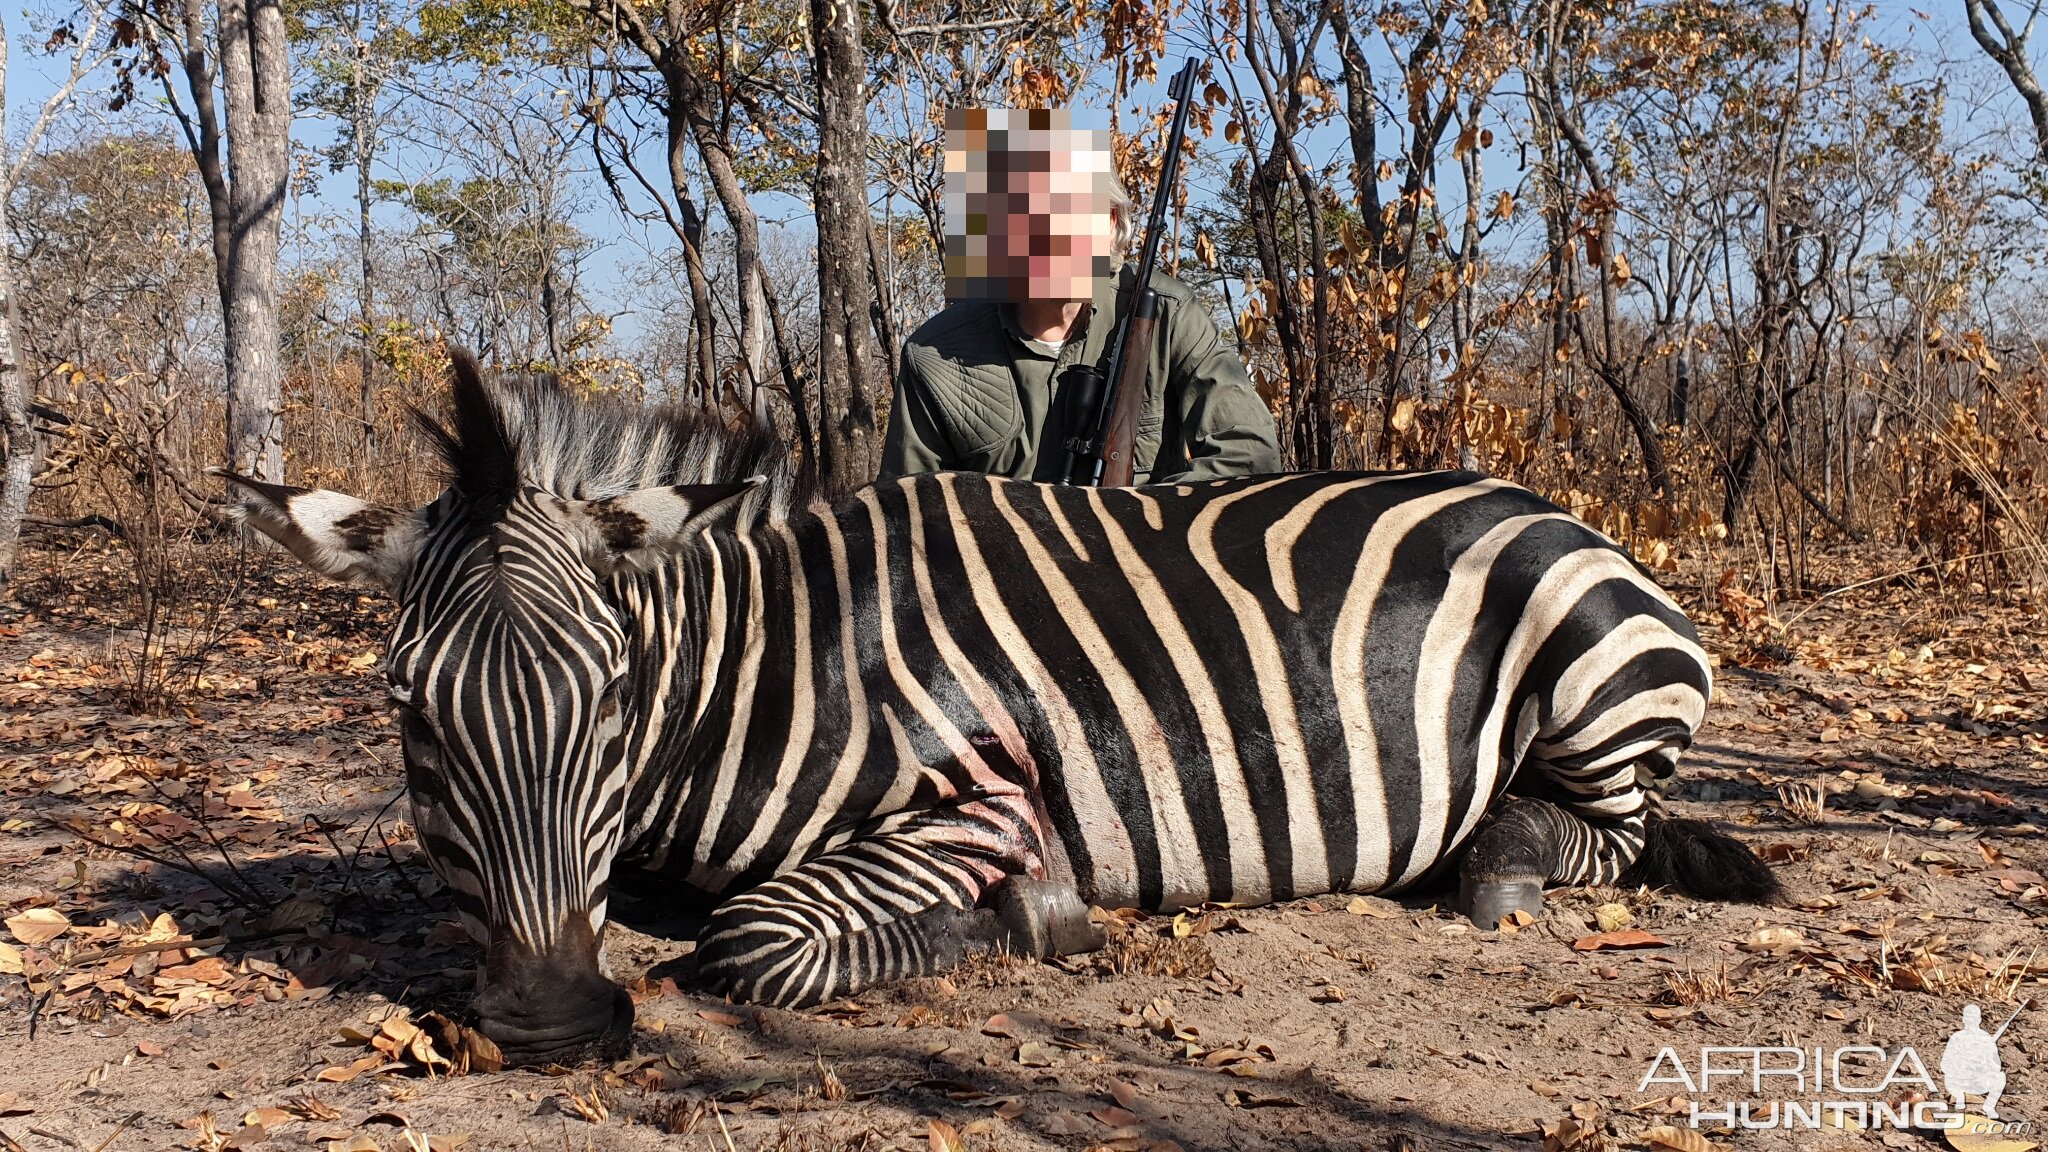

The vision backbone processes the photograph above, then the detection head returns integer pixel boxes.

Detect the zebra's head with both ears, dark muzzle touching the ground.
[229,359,762,1064]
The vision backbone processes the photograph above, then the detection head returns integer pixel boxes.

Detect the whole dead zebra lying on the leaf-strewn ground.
[229,357,1778,1062]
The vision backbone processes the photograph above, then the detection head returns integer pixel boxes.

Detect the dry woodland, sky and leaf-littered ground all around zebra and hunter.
[0,0,2048,1152]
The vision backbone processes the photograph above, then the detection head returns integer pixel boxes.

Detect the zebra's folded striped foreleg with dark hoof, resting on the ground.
[696,838,1102,1009]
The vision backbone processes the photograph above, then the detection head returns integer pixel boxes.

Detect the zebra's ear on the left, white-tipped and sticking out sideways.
[211,467,420,592]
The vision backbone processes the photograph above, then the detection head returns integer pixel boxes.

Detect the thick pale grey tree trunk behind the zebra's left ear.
[219,0,291,482]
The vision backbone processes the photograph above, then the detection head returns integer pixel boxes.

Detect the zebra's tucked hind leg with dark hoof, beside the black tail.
[1458,797,1642,929]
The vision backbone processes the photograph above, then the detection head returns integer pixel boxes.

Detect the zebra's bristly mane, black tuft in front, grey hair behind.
[414,351,809,523]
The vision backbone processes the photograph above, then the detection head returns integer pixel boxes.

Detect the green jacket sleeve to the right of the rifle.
[1149,293,1286,484]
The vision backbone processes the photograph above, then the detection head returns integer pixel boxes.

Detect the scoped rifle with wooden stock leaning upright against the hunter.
[1065,57,1198,488]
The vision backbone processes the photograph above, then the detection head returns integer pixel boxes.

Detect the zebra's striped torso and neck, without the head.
[618,474,1708,1000]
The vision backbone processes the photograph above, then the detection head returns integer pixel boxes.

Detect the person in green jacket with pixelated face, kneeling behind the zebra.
[881,109,1282,484]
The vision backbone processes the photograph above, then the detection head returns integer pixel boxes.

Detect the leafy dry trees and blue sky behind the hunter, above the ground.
[0,0,2048,697]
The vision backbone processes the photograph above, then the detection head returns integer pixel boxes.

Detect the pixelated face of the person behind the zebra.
[946,109,1116,301]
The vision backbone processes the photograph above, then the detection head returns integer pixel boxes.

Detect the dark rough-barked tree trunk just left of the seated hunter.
[806,0,881,494]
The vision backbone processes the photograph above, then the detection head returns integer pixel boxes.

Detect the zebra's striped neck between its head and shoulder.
[621,523,795,873]
